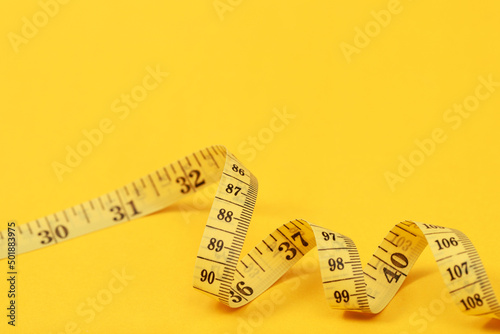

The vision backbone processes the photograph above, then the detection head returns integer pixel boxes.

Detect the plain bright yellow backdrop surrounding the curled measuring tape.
[0,0,500,334]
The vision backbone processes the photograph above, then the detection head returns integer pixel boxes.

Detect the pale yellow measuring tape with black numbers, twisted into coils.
[0,146,500,319]
